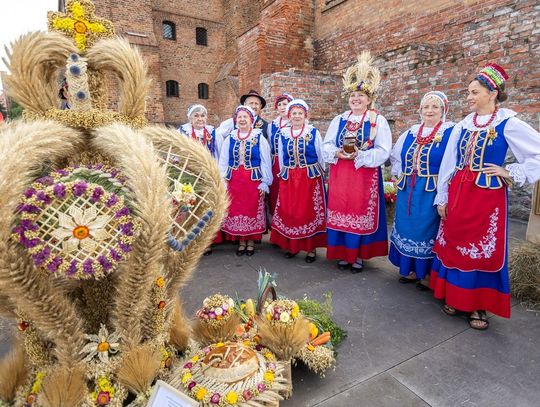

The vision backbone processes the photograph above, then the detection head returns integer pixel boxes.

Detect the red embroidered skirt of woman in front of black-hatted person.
[221,165,266,240]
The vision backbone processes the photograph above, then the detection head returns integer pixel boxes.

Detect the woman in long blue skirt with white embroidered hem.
[388,91,454,289]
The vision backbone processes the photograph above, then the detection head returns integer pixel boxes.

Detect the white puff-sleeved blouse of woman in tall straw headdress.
[323,110,392,169]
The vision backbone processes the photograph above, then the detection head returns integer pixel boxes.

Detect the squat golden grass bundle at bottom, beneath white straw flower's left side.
[40,367,88,407]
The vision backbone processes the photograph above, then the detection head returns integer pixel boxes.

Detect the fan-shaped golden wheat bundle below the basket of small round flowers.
[255,316,309,361]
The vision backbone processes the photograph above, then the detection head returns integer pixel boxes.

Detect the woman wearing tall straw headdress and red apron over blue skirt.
[323,51,392,273]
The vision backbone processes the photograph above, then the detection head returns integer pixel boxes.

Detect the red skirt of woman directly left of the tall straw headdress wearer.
[270,168,326,253]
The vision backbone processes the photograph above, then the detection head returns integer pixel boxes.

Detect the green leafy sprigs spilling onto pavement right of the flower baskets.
[296,292,347,347]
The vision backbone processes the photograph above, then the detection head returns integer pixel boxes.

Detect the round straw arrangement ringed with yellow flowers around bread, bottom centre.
[179,340,285,407]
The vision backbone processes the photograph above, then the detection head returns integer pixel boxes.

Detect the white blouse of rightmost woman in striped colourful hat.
[434,109,540,205]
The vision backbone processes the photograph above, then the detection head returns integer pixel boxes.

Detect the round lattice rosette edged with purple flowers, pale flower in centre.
[12,177,138,279]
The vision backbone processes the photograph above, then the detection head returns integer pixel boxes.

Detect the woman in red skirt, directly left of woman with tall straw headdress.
[270,99,326,263]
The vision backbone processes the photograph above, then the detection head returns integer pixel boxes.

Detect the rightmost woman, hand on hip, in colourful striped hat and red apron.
[430,64,540,330]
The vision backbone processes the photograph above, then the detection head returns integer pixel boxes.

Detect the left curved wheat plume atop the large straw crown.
[4,32,77,113]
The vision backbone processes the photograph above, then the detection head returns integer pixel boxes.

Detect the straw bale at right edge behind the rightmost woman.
[508,242,540,310]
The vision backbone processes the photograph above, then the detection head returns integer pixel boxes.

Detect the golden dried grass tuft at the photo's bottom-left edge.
[0,343,28,403]
